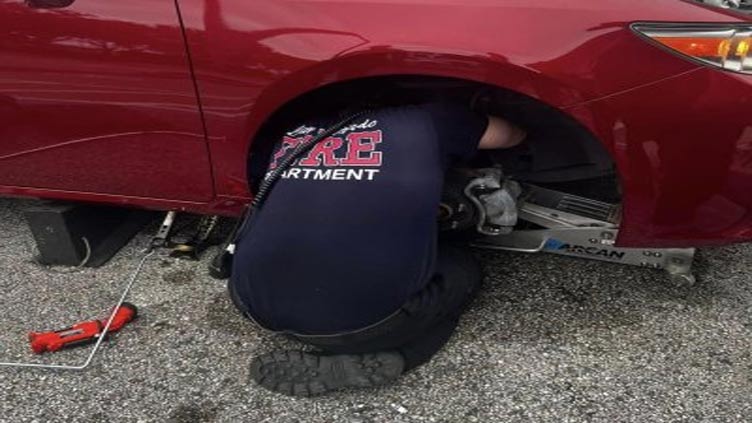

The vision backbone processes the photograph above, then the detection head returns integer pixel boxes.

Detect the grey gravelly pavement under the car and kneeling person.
[0,200,752,423]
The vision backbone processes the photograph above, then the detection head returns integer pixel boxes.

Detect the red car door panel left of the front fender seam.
[0,0,213,201]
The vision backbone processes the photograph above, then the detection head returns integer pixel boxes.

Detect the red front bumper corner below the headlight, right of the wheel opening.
[567,68,752,247]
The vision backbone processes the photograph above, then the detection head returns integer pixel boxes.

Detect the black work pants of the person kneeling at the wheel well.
[230,245,482,370]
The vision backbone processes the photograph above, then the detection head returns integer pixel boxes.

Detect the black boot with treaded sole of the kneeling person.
[251,351,405,397]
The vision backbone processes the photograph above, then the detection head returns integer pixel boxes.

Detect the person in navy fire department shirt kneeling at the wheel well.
[229,103,524,396]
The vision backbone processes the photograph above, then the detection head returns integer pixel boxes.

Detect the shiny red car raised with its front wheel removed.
[0,0,752,274]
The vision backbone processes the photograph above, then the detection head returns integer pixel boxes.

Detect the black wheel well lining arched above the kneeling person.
[249,75,620,202]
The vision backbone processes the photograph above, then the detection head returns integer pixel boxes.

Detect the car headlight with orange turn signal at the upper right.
[632,24,752,74]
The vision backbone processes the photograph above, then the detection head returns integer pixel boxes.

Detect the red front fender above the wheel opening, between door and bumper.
[180,0,728,197]
